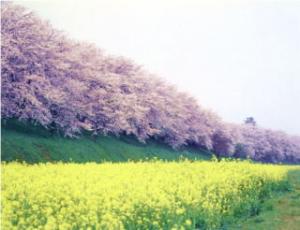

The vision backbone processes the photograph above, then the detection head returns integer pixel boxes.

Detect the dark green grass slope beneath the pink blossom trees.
[1,120,211,163]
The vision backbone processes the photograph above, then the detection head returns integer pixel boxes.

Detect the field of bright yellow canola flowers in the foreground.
[1,160,296,230]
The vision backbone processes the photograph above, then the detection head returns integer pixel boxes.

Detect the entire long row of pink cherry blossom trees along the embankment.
[1,3,300,162]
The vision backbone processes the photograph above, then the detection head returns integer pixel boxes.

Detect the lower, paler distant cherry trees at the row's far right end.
[219,124,300,163]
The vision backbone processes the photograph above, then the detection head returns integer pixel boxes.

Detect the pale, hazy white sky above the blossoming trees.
[18,0,300,135]
